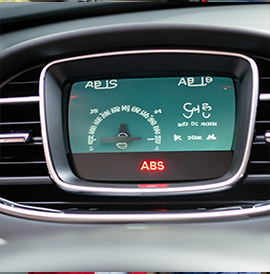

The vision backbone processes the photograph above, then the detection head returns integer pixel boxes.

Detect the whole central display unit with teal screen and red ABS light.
[40,49,255,185]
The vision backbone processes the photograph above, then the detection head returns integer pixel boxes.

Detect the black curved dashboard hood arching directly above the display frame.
[1,25,269,84]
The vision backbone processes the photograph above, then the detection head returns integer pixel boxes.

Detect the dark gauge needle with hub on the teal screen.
[99,124,142,149]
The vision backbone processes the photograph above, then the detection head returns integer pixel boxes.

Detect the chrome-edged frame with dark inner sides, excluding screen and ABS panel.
[40,49,259,196]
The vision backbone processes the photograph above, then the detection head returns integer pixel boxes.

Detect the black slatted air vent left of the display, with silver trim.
[0,68,49,185]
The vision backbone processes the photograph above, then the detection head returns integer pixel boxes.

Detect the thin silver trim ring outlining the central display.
[39,49,259,195]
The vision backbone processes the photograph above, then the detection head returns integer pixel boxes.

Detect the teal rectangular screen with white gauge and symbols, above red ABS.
[68,76,236,154]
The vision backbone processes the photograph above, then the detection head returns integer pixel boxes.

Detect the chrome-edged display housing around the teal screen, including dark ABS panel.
[40,49,258,195]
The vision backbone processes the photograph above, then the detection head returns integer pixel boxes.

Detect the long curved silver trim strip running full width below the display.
[0,198,270,223]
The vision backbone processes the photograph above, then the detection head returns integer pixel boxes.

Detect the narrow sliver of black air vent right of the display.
[248,56,270,184]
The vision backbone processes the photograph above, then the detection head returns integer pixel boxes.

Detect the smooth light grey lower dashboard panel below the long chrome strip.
[0,211,270,272]
